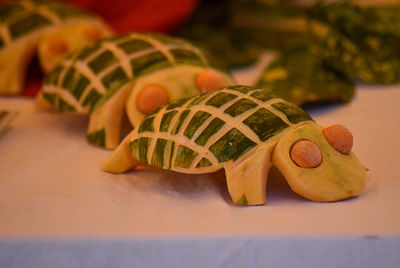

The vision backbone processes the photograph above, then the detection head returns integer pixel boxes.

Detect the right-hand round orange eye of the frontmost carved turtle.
[322,124,353,154]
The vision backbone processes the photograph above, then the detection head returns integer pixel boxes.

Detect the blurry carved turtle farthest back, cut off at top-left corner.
[0,0,111,95]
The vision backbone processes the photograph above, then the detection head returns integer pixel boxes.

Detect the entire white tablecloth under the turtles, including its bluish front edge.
[0,55,400,267]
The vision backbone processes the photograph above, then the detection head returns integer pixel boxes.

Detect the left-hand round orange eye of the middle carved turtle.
[136,84,169,114]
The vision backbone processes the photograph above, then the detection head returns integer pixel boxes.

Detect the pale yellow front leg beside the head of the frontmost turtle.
[224,146,273,205]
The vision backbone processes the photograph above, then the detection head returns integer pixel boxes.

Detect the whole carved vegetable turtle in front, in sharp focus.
[102,86,366,205]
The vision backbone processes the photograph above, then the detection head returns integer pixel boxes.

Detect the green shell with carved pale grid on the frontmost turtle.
[130,86,312,173]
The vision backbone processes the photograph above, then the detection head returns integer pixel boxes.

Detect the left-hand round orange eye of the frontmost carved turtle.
[290,140,322,168]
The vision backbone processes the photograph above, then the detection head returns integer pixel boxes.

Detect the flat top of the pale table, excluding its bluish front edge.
[0,54,400,266]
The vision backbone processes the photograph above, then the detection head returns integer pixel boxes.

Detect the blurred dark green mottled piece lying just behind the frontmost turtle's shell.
[257,46,354,105]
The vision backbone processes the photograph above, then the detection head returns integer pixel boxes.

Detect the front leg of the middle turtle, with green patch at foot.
[87,83,132,149]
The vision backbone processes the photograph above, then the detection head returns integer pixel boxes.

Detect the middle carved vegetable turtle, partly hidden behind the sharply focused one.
[39,33,232,148]
